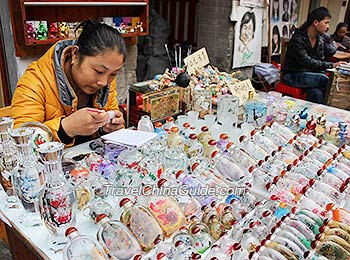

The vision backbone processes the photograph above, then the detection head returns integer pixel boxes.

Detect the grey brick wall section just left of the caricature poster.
[197,0,234,71]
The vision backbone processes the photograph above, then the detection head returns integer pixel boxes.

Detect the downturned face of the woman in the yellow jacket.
[72,50,124,95]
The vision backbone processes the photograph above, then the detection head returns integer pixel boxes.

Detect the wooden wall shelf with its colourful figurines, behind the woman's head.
[9,0,149,56]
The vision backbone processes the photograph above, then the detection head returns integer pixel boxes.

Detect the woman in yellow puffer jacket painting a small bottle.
[11,20,126,146]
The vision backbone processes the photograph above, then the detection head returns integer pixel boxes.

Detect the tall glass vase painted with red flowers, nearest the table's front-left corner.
[38,142,77,251]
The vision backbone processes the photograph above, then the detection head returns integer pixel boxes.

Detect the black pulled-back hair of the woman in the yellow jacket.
[76,19,126,60]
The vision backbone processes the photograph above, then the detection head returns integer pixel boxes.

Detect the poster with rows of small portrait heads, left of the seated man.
[270,0,300,56]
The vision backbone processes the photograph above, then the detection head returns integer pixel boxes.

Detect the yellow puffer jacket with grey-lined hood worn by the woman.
[11,40,118,146]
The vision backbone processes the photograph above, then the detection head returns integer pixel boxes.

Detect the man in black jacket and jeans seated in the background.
[282,7,344,104]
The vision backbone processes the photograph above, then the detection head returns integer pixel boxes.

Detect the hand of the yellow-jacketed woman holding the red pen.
[61,108,109,137]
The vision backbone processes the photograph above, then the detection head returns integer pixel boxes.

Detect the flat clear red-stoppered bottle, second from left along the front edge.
[96,214,141,260]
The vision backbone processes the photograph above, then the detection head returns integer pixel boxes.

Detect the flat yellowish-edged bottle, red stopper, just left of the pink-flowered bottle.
[119,198,164,251]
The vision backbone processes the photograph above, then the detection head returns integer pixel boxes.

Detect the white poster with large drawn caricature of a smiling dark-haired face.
[232,6,263,68]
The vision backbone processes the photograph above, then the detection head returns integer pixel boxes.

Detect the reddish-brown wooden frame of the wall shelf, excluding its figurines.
[9,0,149,56]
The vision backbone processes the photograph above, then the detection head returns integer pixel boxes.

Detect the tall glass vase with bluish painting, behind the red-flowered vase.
[9,127,45,226]
